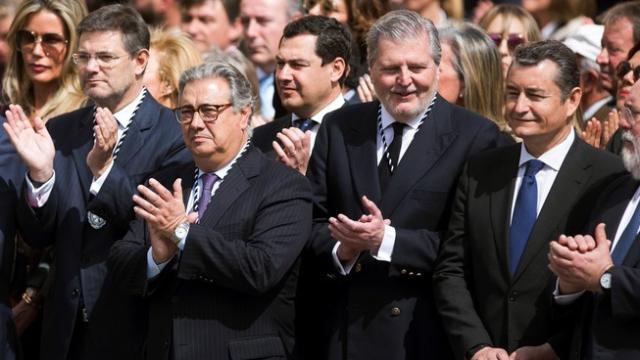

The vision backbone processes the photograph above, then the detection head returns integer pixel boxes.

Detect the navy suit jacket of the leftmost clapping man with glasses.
[19,95,191,359]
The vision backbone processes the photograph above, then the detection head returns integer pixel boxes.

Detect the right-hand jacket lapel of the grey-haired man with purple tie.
[200,146,263,227]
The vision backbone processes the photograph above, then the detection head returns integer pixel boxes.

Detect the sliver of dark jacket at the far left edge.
[0,117,25,360]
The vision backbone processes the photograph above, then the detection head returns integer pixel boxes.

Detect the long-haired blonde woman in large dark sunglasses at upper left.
[2,0,87,121]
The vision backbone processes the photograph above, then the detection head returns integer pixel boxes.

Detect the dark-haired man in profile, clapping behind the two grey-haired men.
[252,16,351,175]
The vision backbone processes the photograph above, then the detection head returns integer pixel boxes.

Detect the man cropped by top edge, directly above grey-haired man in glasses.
[180,0,242,53]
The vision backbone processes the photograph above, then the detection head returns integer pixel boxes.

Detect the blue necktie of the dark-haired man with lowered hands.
[509,160,544,275]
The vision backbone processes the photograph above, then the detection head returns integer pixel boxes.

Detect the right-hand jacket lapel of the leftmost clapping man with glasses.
[116,93,160,164]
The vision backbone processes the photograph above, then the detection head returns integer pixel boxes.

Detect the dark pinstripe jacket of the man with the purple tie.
[110,148,311,360]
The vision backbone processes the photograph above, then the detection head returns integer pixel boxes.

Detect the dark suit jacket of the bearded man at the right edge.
[556,175,640,360]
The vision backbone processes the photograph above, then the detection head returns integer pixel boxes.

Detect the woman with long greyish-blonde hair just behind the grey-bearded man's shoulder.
[438,23,509,138]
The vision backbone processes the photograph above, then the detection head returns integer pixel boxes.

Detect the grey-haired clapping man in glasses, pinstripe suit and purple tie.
[110,64,311,359]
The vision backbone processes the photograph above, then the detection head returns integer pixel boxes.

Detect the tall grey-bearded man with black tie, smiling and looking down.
[298,10,508,359]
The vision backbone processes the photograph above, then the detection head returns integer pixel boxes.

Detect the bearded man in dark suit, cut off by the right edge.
[549,76,640,360]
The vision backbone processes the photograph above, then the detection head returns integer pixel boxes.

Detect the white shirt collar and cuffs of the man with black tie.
[332,101,429,275]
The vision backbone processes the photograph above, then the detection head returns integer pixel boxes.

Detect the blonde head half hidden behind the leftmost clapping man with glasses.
[144,29,202,109]
